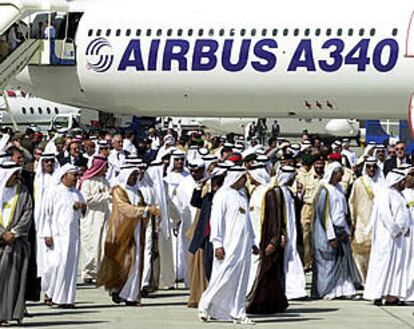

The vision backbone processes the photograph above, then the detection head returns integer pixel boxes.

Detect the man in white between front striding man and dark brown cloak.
[247,164,271,293]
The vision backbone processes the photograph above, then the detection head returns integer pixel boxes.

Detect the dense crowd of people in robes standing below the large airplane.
[0,123,414,325]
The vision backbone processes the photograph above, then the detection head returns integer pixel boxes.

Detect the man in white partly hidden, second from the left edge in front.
[32,153,59,291]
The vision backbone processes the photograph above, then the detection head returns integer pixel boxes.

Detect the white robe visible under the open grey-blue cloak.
[324,184,356,299]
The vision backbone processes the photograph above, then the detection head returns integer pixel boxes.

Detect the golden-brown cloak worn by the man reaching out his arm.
[96,186,146,290]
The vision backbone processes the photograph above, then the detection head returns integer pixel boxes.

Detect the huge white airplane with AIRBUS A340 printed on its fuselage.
[0,0,414,132]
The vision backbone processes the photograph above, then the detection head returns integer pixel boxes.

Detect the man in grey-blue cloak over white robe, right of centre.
[311,162,360,300]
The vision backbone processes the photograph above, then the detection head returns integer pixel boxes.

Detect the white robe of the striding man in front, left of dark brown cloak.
[199,187,255,320]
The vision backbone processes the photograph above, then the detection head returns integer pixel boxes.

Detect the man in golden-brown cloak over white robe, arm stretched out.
[97,165,160,306]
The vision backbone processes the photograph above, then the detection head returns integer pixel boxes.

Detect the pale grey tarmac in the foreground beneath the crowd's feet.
[23,284,414,329]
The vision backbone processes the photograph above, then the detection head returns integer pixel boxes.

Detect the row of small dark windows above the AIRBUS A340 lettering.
[88,28,398,37]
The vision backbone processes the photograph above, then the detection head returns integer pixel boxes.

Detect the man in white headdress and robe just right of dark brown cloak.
[277,166,306,300]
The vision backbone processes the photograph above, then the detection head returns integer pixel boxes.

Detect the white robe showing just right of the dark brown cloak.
[282,186,306,300]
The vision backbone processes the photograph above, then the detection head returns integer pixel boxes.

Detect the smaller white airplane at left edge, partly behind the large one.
[0,90,85,130]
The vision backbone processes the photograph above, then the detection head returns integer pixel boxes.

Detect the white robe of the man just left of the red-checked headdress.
[46,183,85,304]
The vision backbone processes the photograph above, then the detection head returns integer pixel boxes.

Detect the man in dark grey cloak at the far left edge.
[0,162,32,326]
